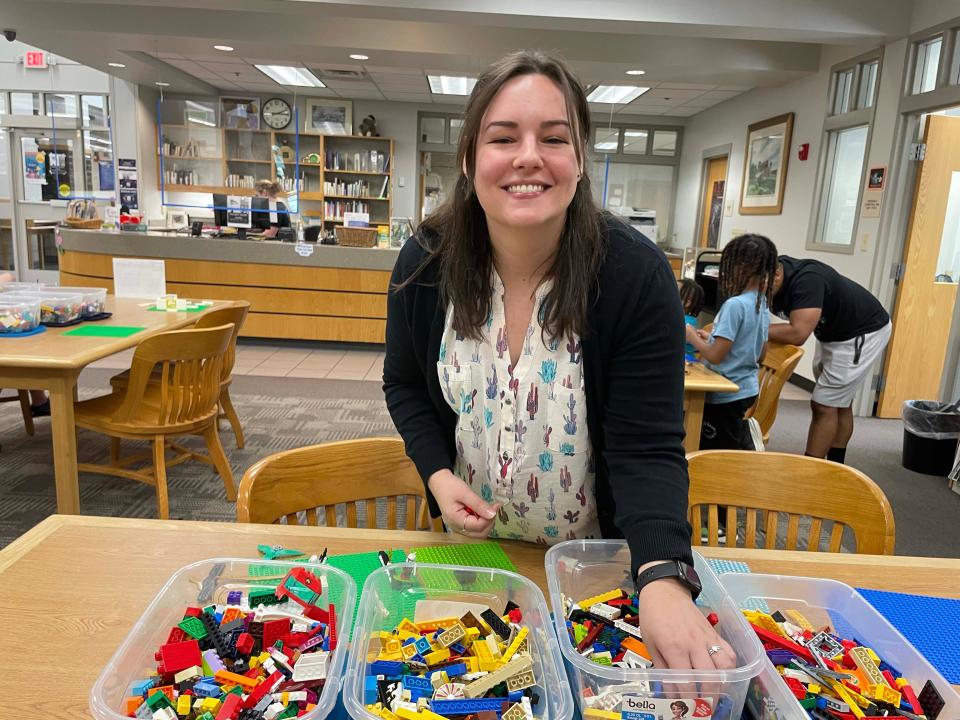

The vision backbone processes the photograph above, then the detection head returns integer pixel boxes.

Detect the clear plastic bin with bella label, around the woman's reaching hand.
[546,540,766,720]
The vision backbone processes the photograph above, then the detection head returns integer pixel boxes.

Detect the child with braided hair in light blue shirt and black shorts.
[687,235,777,450]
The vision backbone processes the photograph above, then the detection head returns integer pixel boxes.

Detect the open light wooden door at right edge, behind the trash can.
[877,115,960,418]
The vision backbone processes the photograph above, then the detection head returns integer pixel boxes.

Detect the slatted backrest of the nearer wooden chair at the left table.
[114,325,233,428]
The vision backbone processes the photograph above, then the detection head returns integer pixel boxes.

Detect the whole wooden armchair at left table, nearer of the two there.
[74,325,237,518]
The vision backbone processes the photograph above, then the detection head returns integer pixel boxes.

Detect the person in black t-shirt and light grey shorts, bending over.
[770,255,892,463]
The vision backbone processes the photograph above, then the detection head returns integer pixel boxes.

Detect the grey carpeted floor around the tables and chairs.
[0,370,960,557]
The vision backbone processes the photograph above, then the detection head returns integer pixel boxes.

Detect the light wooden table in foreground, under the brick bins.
[0,515,960,720]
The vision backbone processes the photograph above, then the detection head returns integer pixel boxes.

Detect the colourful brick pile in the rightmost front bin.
[743,609,944,720]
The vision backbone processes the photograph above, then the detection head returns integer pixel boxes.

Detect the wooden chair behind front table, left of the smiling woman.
[237,438,443,531]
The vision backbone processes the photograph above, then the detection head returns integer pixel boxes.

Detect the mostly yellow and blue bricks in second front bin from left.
[364,603,540,720]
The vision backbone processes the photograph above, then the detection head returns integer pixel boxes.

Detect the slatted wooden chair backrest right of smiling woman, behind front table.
[687,450,896,555]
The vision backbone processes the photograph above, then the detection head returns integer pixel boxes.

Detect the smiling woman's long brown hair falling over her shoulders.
[396,50,606,340]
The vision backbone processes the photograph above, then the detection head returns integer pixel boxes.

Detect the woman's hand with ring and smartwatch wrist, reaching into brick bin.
[639,578,737,670]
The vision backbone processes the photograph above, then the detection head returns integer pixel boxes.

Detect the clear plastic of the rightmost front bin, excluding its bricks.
[720,573,960,719]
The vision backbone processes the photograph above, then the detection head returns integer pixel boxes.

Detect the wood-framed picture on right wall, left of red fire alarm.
[740,113,793,215]
